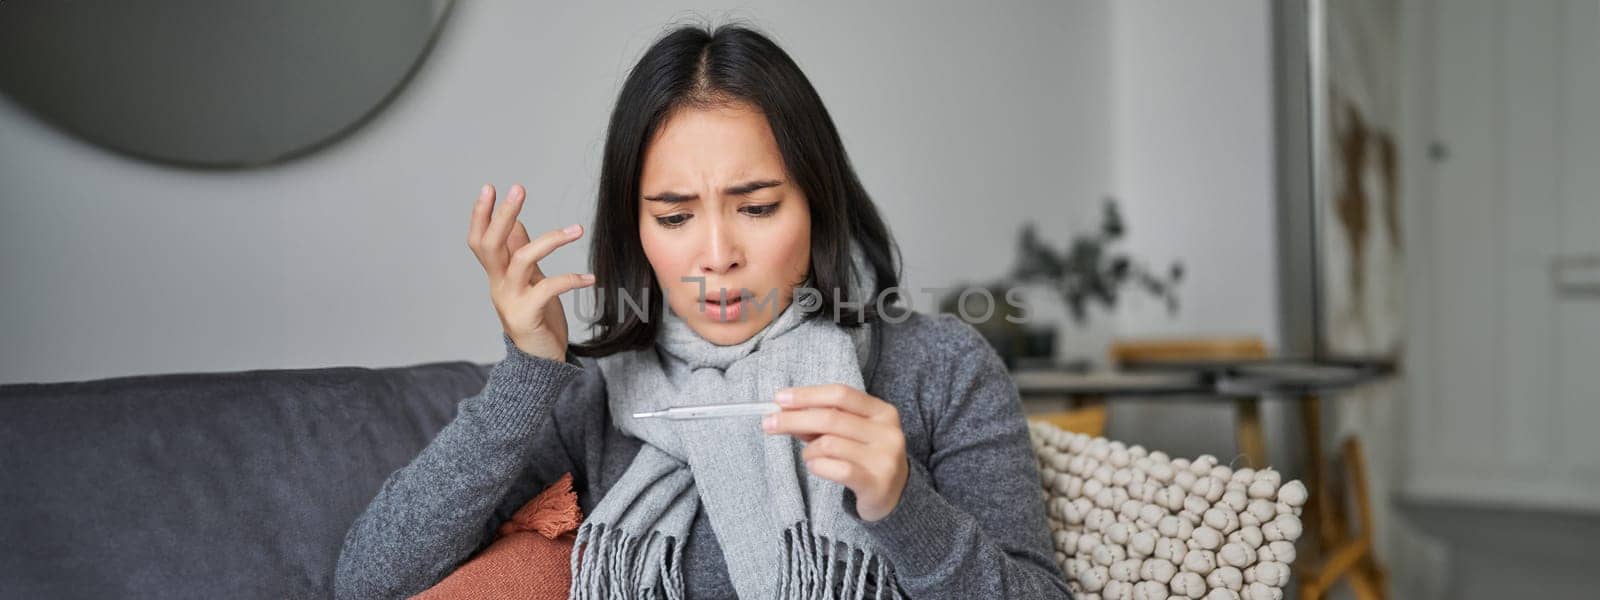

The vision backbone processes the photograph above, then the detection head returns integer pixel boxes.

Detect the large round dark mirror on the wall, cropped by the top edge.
[0,0,454,168]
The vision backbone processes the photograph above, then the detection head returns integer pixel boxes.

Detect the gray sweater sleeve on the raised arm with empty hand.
[334,333,584,598]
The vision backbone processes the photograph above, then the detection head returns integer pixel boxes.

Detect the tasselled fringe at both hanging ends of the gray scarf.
[568,520,901,600]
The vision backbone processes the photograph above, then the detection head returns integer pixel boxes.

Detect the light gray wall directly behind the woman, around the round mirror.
[0,0,1113,382]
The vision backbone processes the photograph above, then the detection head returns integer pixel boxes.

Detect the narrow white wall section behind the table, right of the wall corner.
[1107,0,1290,466]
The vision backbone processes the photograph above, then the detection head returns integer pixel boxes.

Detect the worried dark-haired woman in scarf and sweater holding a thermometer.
[336,26,1067,598]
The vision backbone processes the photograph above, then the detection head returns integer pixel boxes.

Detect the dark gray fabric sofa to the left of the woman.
[0,362,493,598]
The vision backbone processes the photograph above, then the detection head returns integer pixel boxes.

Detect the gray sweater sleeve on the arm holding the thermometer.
[845,316,1070,598]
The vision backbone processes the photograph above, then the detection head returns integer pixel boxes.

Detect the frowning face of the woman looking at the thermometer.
[638,104,811,346]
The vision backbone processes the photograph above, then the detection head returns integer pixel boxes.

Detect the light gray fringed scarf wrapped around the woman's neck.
[570,254,899,600]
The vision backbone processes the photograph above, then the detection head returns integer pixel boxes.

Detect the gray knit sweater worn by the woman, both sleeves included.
[334,314,1069,598]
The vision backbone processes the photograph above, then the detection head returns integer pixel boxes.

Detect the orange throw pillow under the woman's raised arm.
[413,474,582,600]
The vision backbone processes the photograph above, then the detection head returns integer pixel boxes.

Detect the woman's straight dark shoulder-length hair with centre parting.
[571,24,901,357]
